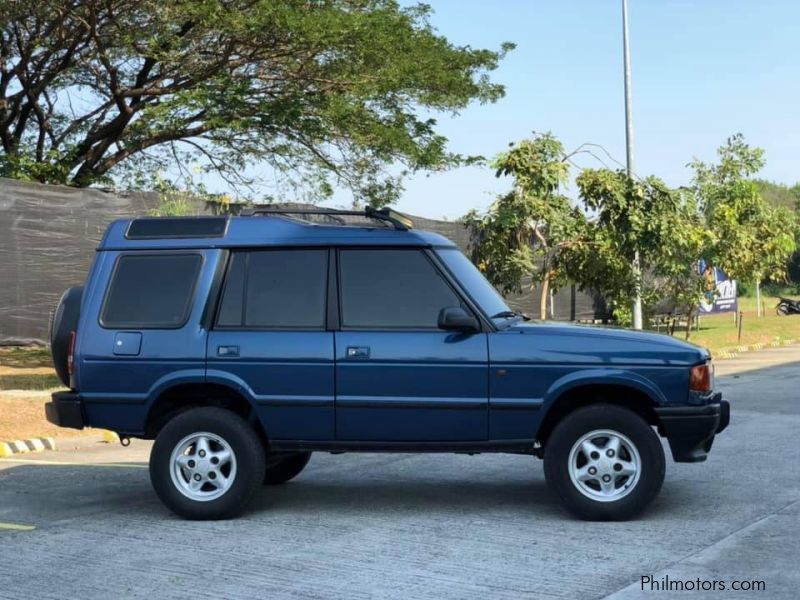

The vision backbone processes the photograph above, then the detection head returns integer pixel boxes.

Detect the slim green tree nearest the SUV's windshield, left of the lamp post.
[465,133,585,320]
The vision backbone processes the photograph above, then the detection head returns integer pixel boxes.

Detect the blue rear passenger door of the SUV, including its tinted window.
[207,248,335,440]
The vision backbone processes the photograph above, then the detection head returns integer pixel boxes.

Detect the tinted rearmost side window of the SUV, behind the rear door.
[102,254,202,328]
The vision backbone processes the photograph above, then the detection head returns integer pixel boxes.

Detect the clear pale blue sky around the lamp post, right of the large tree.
[337,0,800,219]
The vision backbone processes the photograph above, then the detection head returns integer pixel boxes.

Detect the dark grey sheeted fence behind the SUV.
[0,178,607,344]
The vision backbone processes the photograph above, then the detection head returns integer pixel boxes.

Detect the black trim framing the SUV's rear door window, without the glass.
[212,246,332,331]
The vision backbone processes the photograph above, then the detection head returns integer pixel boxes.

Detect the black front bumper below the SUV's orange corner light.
[656,392,731,462]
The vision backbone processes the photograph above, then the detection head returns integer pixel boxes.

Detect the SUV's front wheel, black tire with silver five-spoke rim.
[544,404,666,521]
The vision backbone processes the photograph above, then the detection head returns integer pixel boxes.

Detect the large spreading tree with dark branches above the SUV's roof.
[0,0,512,204]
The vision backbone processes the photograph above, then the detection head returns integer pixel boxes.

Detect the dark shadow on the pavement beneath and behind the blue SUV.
[0,462,565,523]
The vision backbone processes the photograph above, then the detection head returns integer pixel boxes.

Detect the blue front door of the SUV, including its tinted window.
[336,249,488,442]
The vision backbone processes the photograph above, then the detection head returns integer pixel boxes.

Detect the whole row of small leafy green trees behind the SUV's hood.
[466,134,797,336]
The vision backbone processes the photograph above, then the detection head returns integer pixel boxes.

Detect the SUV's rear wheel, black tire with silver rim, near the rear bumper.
[150,407,264,520]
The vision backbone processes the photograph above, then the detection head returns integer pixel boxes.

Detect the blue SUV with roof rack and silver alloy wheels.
[46,208,729,520]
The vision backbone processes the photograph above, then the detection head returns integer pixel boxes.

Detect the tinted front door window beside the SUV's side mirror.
[339,250,461,329]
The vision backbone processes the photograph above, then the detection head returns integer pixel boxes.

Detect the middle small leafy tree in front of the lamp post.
[567,169,710,330]
